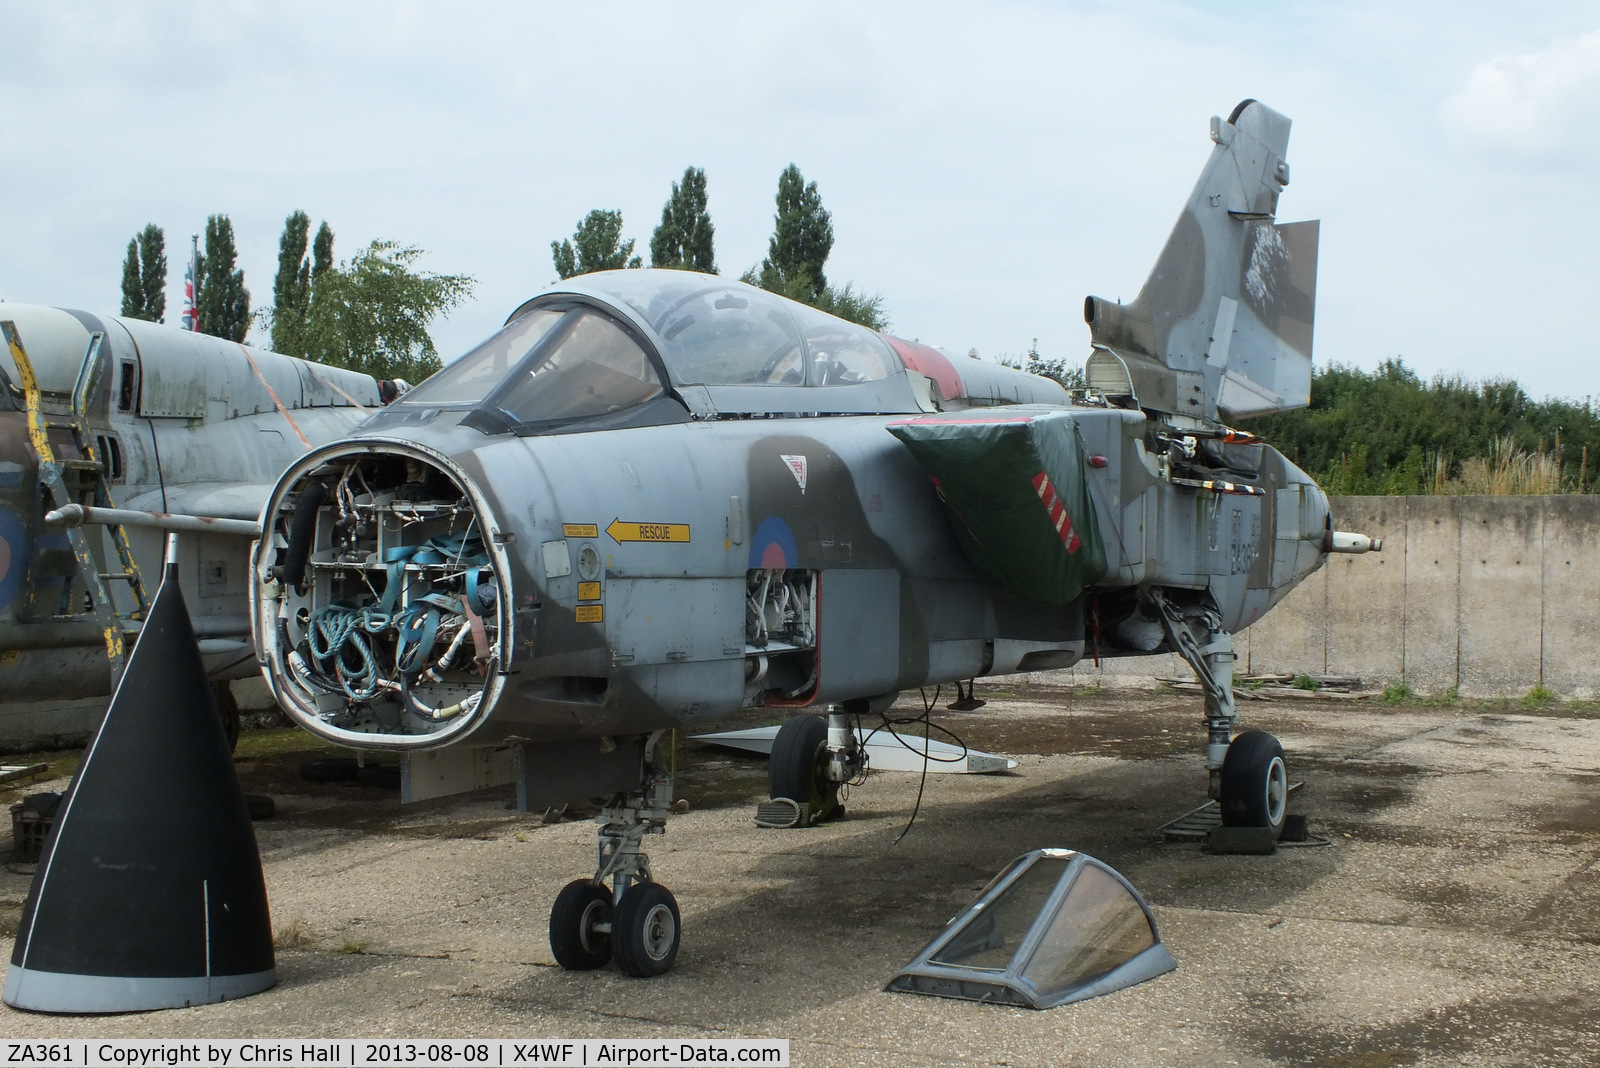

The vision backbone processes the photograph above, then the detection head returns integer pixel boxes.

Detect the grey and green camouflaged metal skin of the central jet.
[253,101,1358,771]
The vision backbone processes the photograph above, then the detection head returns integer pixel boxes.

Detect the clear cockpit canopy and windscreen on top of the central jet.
[379,270,1064,433]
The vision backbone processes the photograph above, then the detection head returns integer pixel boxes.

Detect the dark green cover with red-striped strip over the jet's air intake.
[888,409,1106,604]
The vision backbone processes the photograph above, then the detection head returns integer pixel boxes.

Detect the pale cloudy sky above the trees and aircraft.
[0,0,1600,398]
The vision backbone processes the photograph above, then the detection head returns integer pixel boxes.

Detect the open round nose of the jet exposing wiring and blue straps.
[251,440,514,750]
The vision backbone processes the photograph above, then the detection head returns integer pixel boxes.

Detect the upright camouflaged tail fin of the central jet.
[1083,101,1318,419]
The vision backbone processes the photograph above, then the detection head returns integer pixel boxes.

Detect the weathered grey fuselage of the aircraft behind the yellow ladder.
[0,304,381,705]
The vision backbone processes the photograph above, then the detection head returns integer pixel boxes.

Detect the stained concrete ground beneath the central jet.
[0,684,1600,1068]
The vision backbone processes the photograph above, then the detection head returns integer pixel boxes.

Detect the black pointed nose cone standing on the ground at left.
[0,563,277,1012]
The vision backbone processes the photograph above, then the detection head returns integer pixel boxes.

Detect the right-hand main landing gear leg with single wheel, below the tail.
[1149,590,1290,833]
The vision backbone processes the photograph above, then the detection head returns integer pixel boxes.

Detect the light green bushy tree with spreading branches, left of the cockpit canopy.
[294,238,475,382]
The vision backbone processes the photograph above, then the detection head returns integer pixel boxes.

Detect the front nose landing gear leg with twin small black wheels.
[550,731,682,977]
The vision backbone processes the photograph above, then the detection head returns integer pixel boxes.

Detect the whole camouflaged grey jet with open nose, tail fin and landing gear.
[251,101,1370,974]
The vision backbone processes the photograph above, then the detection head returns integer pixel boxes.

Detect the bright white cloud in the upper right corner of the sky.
[1440,30,1600,160]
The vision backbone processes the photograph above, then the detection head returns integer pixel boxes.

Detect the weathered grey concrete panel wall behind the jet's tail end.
[1238,496,1600,697]
